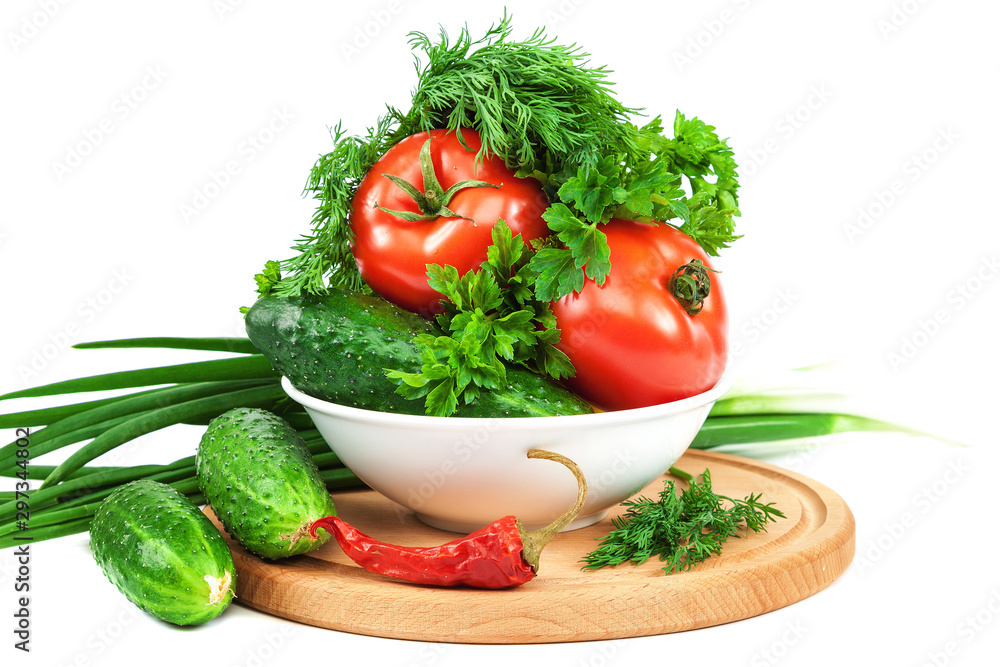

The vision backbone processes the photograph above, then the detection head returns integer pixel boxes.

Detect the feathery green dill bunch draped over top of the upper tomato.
[402,13,637,176]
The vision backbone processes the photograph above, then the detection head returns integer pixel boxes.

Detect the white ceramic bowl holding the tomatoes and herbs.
[282,377,730,533]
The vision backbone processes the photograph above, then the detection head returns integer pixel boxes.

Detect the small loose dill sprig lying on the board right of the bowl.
[583,468,785,574]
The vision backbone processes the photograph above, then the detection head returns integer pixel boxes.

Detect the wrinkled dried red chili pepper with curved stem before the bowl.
[309,449,587,588]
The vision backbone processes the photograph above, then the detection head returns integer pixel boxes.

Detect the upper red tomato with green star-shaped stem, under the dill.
[350,130,549,315]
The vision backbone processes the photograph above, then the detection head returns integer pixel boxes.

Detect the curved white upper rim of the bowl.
[281,369,735,430]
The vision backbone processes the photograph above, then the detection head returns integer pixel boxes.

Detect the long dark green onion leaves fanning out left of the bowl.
[0,338,372,548]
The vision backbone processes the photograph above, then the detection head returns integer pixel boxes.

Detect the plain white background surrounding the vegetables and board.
[0,0,1000,665]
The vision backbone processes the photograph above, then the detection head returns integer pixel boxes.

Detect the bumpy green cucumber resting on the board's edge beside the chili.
[195,408,337,560]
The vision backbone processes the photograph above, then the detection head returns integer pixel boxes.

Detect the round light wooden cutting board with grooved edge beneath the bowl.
[206,450,855,644]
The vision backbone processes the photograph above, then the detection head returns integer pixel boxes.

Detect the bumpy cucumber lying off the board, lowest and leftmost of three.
[90,480,236,625]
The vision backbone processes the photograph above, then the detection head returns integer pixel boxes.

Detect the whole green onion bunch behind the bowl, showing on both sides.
[0,338,932,549]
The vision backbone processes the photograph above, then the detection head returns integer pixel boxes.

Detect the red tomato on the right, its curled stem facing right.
[552,220,729,410]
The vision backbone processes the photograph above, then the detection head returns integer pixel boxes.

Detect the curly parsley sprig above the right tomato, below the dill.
[532,112,739,300]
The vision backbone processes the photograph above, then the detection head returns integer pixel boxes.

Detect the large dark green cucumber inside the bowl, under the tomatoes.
[246,290,593,417]
